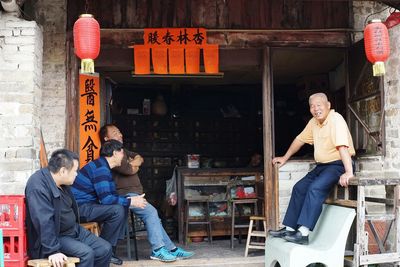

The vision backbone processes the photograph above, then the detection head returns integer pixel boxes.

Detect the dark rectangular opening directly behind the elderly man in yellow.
[272,48,346,159]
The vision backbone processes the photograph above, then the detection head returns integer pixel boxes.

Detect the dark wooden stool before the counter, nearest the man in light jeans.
[184,197,212,245]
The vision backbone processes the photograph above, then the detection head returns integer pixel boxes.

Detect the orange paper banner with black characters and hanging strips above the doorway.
[133,28,219,75]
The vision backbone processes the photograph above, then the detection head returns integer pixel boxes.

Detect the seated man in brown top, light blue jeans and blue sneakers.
[99,124,194,262]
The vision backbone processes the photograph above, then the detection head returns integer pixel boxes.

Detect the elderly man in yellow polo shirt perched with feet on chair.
[269,93,355,245]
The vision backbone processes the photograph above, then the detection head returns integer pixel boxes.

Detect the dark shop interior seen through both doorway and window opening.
[98,48,344,211]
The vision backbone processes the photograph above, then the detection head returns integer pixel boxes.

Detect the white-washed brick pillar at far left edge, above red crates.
[0,11,43,195]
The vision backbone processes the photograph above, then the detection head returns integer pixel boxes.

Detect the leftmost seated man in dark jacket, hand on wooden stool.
[25,149,112,267]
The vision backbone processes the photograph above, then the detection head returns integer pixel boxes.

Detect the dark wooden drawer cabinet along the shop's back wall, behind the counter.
[113,114,261,207]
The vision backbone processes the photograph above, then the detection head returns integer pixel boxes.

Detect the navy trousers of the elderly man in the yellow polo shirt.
[283,160,345,231]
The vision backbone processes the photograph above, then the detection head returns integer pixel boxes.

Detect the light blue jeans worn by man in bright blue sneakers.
[127,193,175,250]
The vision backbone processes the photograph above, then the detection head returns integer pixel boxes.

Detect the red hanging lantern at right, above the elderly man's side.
[364,20,390,76]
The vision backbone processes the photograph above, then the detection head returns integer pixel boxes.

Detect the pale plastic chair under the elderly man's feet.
[265,204,356,267]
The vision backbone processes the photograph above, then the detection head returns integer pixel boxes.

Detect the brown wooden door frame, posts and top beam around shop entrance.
[65,29,350,231]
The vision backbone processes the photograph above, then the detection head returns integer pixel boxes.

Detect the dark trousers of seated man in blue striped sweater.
[79,203,128,247]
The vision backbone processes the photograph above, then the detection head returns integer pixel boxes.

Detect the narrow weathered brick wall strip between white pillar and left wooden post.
[34,0,67,154]
